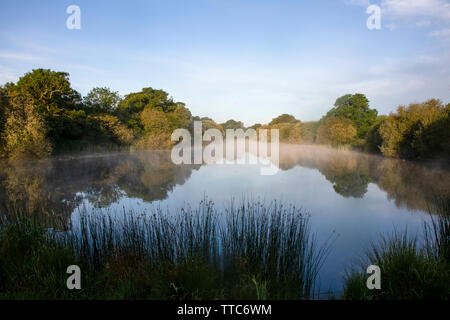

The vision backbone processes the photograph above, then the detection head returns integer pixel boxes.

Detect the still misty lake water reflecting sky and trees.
[0,146,450,292]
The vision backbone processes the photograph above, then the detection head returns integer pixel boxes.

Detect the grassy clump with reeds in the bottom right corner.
[343,198,450,300]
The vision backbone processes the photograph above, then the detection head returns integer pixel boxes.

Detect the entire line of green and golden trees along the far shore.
[0,69,450,159]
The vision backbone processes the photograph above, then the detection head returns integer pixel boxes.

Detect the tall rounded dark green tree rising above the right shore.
[325,93,378,139]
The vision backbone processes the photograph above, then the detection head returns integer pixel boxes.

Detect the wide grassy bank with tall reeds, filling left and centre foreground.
[0,201,330,299]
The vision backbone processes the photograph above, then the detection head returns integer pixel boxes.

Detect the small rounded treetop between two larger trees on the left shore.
[83,87,122,114]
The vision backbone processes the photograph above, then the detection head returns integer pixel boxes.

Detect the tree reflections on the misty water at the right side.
[280,145,450,211]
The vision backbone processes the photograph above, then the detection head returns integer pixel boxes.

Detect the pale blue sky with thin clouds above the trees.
[0,0,450,125]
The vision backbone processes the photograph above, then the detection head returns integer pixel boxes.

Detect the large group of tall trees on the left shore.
[0,69,192,157]
